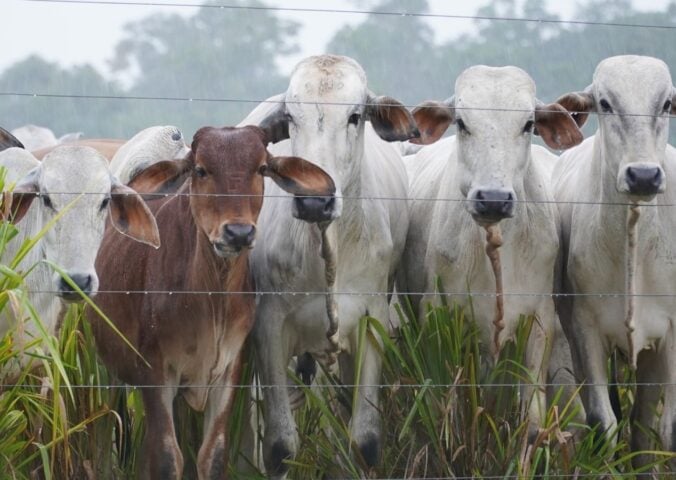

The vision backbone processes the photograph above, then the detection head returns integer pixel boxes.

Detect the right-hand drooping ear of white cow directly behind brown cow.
[364,93,420,142]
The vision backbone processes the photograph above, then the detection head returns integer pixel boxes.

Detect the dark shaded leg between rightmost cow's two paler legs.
[631,350,664,467]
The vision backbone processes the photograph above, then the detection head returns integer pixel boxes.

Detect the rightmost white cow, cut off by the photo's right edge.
[553,56,676,463]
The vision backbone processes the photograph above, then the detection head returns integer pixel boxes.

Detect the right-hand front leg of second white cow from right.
[522,312,556,443]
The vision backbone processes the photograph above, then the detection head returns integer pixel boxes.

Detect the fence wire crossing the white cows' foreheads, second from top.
[0,91,674,118]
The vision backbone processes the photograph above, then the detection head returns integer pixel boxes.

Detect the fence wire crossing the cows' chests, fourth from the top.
[14,290,676,298]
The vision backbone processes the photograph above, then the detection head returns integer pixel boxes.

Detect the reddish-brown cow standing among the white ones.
[89,127,335,480]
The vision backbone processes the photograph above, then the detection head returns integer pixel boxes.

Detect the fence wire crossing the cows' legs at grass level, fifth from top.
[0,382,676,390]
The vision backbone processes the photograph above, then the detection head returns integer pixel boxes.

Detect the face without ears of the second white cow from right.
[455,66,536,223]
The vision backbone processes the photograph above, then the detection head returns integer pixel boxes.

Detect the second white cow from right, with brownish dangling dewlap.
[404,66,582,436]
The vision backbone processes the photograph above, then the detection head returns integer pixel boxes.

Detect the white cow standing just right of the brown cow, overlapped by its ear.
[241,55,417,477]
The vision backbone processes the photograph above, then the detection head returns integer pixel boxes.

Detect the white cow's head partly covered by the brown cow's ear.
[243,55,418,222]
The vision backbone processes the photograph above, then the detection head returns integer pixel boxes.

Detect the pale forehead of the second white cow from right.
[455,65,536,117]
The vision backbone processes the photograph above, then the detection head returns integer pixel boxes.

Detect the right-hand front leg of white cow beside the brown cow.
[343,310,388,467]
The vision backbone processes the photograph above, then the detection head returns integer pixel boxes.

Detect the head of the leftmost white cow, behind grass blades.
[5,146,160,300]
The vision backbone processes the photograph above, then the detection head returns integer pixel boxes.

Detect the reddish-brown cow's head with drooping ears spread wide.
[130,126,335,257]
